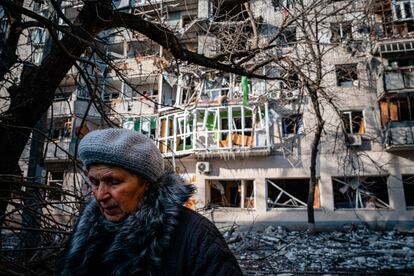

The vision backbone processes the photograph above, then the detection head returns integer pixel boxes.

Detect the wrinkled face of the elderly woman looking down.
[88,165,148,222]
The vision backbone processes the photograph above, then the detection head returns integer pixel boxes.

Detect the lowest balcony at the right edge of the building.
[384,121,414,151]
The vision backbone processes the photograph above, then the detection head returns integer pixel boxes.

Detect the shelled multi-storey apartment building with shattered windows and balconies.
[17,0,414,227]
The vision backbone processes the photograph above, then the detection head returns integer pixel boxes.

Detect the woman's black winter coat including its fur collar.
[62,173,242,275]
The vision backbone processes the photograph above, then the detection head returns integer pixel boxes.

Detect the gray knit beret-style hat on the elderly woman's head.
[79,128,164,183]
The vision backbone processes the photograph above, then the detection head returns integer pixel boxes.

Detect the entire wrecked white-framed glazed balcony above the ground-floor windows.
[158,104,270,157]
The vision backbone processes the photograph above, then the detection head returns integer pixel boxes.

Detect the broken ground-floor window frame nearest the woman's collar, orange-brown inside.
[206,179,256,210]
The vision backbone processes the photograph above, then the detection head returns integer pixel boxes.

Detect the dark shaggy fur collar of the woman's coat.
[62,173,194,275]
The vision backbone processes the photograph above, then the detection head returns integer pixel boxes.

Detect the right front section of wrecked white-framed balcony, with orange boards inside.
[195,103,270,157]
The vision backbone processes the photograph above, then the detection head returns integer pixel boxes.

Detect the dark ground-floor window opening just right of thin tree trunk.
[332,176,389,209]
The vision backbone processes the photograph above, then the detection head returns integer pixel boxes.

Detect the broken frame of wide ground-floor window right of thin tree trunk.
[332,176,391,210]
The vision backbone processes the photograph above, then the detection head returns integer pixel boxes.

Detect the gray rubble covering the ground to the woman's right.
[224,226,414,275]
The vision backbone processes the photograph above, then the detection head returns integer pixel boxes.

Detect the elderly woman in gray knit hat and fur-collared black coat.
[62,129,242,275]
